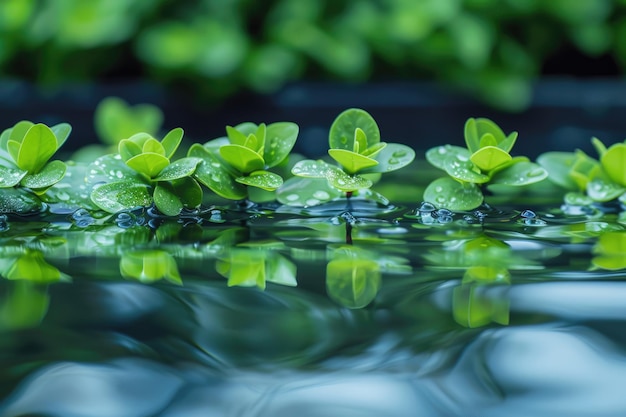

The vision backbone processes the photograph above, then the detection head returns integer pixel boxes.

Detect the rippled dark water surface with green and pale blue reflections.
[0,200,626,417]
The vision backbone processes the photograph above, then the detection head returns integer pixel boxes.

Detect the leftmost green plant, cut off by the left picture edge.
[0,120,72,195]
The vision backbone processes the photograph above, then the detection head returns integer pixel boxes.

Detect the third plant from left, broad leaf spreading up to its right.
[188,122,299,200]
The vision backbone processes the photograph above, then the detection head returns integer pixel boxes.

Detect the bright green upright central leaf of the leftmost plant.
[15,123,57,174]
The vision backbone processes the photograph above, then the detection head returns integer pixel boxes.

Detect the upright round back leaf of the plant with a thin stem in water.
[328,109,380,151]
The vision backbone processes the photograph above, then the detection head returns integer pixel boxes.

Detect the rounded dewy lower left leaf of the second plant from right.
[424,177,484,211]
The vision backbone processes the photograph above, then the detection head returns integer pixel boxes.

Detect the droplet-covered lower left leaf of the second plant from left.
[91,181,152,213]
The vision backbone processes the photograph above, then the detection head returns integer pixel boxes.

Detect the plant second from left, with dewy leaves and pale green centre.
[88,128,202,216]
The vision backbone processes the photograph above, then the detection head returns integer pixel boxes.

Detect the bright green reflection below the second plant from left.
[120,249,182,284]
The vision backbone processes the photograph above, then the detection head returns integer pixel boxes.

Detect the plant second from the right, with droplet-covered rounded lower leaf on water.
[424,118,548,210]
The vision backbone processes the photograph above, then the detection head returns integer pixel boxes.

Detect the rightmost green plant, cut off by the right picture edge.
[537,138,626,204]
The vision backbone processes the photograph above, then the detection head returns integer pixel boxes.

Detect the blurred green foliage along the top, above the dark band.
[0,0,626,110]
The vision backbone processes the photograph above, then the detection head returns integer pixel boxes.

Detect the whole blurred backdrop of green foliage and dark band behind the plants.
[0,0,626,156]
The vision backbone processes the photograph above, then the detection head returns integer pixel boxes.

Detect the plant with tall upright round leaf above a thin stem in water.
[278,109,415,205]
